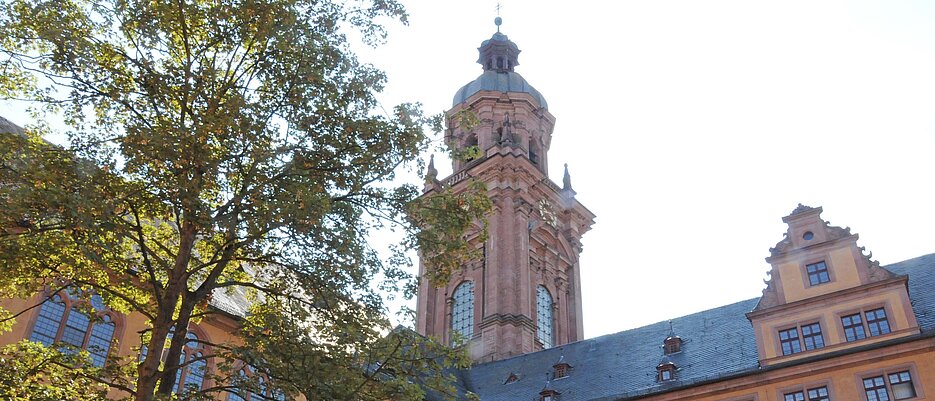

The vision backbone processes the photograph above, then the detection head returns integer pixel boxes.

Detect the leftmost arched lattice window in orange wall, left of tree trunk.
[29,287,117,367]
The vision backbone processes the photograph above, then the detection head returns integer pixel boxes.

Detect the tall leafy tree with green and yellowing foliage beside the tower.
[0,0,490,400]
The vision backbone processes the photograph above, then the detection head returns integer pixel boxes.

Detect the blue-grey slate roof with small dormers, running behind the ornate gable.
[442,254,935,401]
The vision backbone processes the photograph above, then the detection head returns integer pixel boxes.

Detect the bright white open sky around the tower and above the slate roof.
[362,0,935,337]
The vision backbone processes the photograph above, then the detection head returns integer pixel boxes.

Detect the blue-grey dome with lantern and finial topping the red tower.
[452,17,549,109]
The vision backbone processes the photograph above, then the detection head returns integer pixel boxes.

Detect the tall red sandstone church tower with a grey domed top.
[416,17,595,362]
